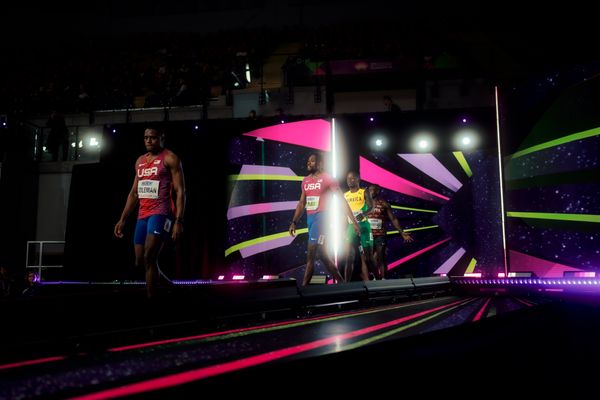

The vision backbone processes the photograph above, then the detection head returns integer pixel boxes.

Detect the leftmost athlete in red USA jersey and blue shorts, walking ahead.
[114,128,185,298]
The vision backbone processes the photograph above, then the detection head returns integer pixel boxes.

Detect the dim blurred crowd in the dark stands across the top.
[0,24,464,115]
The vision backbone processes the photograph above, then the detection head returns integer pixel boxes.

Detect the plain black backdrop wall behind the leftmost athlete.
[64,121,236,281]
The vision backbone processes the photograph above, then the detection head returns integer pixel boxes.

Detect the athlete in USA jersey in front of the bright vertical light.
[289,154,359,286]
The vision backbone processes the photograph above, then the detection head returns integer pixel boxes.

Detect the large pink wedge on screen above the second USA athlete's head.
[244,119,331,151]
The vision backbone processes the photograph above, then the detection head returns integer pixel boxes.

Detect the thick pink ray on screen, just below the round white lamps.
[360,157,450,203]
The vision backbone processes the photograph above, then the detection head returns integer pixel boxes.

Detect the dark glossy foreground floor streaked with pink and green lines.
[0,296,552,399]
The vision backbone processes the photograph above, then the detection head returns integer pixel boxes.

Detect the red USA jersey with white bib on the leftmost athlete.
[135,149,173,219]
